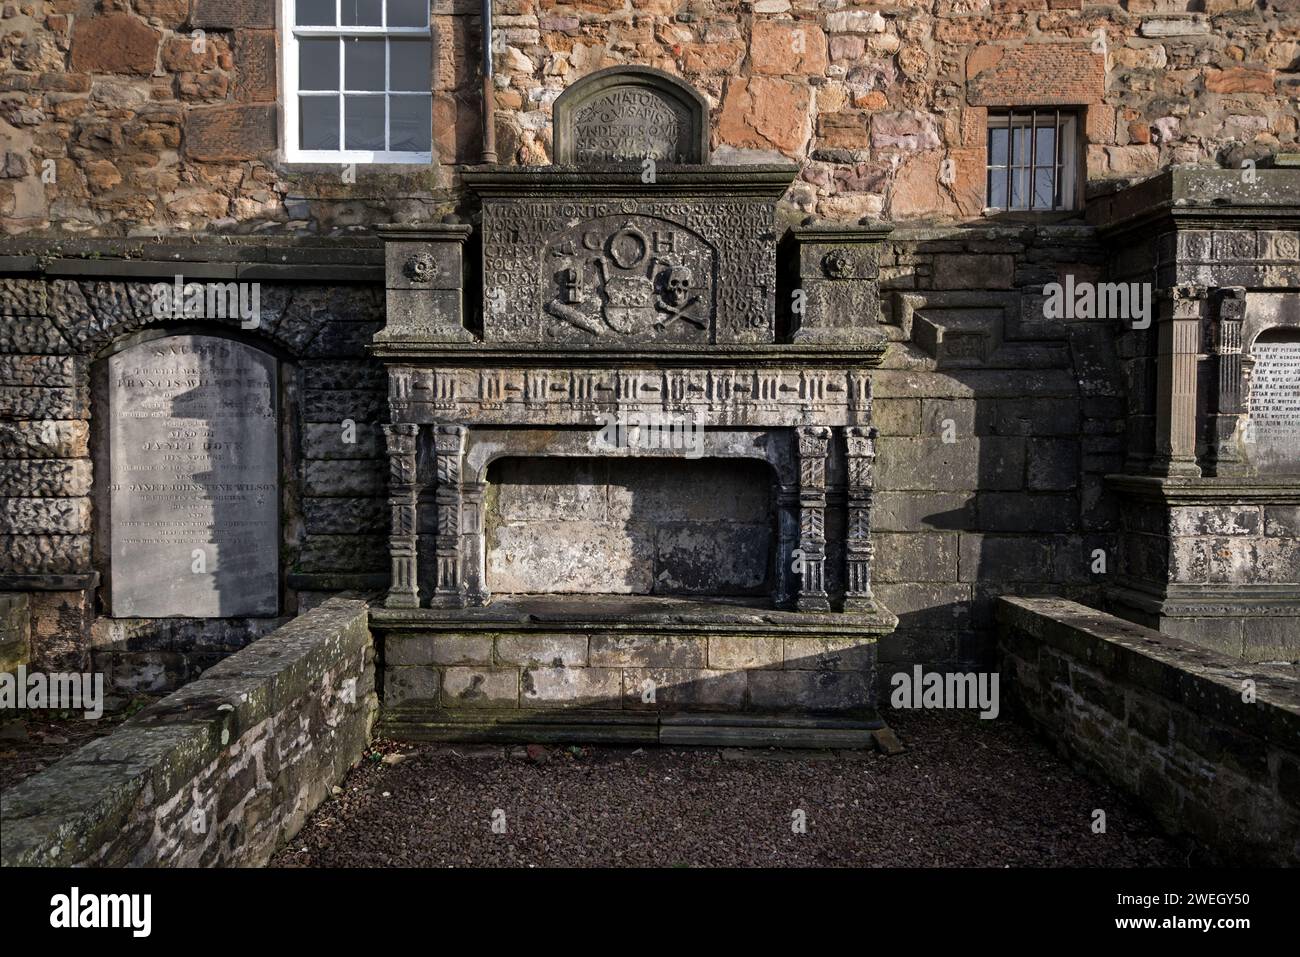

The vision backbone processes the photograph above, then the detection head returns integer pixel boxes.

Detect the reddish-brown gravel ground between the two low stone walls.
[272,711,1196,867]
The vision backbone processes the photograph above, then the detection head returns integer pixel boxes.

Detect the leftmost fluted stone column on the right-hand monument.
[1151,285,1205,477]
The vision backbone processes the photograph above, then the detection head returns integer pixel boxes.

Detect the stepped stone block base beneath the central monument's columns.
[371,596,897,748]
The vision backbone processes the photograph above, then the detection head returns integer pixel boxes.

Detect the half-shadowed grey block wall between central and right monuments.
[872,254,1126,687]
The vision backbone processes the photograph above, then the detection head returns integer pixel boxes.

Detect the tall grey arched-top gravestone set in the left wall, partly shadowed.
[108,335,280,618]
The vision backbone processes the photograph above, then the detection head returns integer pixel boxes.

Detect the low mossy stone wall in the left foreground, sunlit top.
[0,598,378,866]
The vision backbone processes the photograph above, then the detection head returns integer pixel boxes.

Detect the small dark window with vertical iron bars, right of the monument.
[985,108,1079,212]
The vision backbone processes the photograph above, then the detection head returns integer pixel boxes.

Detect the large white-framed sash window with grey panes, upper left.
[283,0,433,163]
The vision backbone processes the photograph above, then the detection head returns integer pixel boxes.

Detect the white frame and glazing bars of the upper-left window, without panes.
[280,0,433,165]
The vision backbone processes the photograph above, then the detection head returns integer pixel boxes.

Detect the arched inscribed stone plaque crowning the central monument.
[554,66,709,166]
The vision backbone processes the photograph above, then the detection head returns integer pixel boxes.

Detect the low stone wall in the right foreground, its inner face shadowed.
[996,598,1300,866]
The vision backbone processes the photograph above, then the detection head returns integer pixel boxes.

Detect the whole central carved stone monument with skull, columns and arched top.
[372,68,897,742]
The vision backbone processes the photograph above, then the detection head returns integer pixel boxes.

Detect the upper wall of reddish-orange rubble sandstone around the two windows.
[0,0,1300,234]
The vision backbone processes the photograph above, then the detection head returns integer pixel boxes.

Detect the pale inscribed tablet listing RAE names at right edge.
[1247,339,1300,472]
